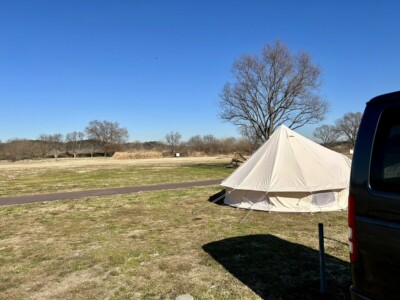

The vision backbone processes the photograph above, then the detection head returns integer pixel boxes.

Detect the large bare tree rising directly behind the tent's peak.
[219,40,328,141]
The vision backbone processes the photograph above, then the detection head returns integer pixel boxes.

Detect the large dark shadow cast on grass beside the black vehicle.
[203,235,351,299]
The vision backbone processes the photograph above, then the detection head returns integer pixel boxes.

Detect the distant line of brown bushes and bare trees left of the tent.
[0,134,252,161]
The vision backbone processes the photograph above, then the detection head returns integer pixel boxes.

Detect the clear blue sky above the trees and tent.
[0,0,400,141]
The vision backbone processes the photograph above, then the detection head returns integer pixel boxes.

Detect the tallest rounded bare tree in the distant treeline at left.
[85,120,129,156]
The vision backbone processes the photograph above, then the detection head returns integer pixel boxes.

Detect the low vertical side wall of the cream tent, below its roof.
[224,188,349,212]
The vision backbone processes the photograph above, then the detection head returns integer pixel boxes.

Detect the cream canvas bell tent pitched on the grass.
[221,125,351,212]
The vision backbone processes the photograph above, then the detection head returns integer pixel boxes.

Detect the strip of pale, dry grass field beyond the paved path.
[0,157,232,197]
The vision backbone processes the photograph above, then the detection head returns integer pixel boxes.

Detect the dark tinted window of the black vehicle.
[370,107,400,192]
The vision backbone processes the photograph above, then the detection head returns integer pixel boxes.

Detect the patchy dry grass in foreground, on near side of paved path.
[0,158,350,299]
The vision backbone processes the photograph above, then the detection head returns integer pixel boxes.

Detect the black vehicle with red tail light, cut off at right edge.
[348,92,400,299]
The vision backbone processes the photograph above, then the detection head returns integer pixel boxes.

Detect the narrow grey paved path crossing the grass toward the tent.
[0,179,222,206]
